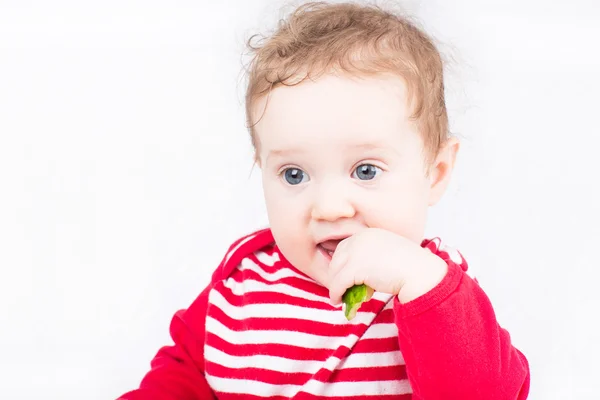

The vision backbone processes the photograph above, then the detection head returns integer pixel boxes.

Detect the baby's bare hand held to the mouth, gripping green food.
[329,228,448,305]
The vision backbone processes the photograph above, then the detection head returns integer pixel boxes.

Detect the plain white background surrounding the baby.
[0,0,600,400]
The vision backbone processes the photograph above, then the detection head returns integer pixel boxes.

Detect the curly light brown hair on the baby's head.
[245,2,448,164]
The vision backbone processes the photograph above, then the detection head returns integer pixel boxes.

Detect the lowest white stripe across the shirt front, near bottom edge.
[207,375,412,397]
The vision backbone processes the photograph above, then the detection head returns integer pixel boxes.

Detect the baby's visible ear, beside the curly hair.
[429,137,460,206]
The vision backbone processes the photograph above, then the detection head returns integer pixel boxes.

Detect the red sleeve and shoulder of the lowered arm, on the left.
[117,229,273,400]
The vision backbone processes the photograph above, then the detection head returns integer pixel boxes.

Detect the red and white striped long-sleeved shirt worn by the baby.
[121,230,529,400]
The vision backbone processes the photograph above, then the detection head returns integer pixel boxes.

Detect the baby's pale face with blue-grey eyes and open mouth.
[255,75,442,286]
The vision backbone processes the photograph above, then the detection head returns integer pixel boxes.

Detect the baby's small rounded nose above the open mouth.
[311,185,356,222]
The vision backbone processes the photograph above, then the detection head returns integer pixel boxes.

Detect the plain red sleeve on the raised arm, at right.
[394,257,530,400]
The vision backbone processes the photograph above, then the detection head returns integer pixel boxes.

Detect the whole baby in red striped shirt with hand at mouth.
[120,3,530,400]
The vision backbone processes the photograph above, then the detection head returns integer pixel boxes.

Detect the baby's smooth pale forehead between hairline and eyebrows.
[254,75,413,153]
